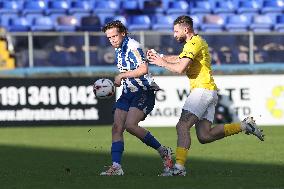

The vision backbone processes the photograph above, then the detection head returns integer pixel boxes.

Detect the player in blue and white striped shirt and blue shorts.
[100,20,173,176]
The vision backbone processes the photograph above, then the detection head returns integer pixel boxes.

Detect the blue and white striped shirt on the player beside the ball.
[115,37,153,93]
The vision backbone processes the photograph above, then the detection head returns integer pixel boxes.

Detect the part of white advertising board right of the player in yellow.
[215,75,284,125]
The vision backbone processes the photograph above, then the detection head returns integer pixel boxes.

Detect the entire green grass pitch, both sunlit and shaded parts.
[0,126,284,189]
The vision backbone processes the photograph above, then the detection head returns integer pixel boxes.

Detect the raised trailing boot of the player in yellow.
[241,117,264,141]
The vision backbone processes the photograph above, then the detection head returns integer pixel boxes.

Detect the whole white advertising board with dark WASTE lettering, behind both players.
[135,75,284,126]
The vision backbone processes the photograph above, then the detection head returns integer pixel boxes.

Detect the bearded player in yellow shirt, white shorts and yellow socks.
[147,16,264,176]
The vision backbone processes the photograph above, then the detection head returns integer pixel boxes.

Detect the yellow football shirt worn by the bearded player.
[179,35,217,90]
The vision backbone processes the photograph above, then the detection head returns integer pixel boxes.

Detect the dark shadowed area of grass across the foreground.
[0,145,284,189]
